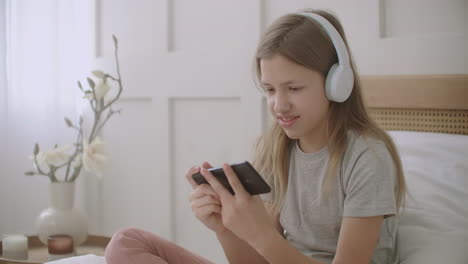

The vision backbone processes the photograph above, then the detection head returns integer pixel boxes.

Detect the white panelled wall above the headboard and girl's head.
[265,0,468,75]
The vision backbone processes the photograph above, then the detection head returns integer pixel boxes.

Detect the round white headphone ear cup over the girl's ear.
[325,63,354,103]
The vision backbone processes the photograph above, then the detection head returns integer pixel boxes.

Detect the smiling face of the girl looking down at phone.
[260,55,329,152]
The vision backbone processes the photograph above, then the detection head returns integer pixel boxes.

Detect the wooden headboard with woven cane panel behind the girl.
[361,74,468,135]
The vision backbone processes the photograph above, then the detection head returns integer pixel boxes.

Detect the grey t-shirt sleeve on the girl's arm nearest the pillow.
[343,144,396,217]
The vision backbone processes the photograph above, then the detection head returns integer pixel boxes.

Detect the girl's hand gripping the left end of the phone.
[185,162,225,233]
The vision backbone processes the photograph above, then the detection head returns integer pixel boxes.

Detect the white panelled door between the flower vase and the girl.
[92,0,262,263]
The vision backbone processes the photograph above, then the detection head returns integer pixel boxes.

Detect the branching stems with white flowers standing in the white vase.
[25,36,123,182]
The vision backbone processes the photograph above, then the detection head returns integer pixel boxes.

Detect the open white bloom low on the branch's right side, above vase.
[82,137,108,179]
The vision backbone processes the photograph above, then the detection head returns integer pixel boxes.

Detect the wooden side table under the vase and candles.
[0,235,110,264]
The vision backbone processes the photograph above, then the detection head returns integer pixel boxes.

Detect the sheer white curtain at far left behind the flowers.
[0,0,92,234]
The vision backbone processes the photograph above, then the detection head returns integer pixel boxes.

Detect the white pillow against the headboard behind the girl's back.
[389,131,468,264]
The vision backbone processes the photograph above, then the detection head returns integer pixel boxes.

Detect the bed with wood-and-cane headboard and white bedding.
[44,75,468,264]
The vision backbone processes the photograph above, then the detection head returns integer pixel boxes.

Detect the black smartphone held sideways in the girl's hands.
[192,161,271,195]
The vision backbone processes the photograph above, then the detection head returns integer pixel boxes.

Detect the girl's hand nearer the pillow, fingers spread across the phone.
[201,163,276,245]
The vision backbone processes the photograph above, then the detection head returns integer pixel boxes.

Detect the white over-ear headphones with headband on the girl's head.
[299,13,354,103]
